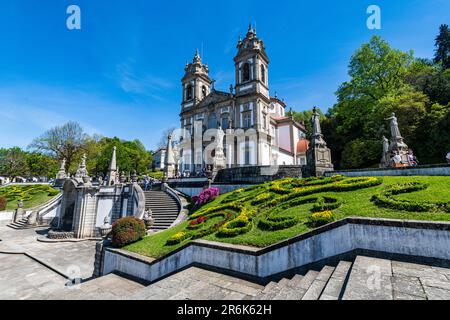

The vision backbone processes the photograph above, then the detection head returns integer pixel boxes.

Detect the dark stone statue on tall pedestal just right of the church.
[306,107,334,176]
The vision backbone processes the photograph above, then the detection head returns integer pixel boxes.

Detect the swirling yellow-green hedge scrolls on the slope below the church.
[162,176,382,245]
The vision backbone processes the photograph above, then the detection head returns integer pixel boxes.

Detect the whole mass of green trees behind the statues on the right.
[322,32,450,168]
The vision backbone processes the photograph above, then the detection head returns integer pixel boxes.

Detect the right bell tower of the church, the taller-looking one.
[234,24,270,99]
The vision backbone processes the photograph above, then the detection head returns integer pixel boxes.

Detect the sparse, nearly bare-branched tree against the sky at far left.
[29,121,88,170]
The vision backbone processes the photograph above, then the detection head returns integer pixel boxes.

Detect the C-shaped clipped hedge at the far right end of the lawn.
[371,182,450,212]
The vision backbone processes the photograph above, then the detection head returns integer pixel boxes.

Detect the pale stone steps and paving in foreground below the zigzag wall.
[120,256,450,300]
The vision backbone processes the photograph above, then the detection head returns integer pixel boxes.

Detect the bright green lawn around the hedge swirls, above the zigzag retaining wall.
[125,176,450,258]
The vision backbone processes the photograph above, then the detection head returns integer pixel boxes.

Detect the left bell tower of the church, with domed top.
[181,49,211,112]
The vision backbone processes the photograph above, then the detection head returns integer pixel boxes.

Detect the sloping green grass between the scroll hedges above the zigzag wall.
[125,176,450,258]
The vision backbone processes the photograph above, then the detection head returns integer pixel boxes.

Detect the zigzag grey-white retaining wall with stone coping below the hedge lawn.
[102,218,450,282]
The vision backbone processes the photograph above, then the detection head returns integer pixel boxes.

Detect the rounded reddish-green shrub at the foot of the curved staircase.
[112,217,147,248]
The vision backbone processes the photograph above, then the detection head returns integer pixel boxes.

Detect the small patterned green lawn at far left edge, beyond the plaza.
[0,185,59,210]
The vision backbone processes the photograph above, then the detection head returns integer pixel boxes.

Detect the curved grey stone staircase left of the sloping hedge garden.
[144,191,180,231]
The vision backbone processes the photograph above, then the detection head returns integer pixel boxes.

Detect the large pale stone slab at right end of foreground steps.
[342,256,393,300]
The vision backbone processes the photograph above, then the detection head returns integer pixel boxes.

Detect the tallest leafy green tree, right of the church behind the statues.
[325,36,413,168]
